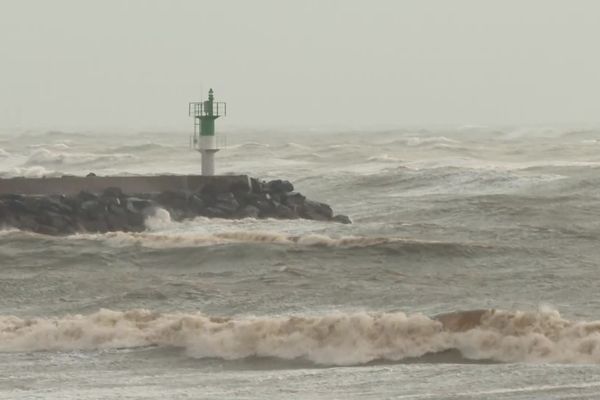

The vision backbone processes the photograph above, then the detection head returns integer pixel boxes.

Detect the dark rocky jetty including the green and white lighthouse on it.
[0,89,351,235]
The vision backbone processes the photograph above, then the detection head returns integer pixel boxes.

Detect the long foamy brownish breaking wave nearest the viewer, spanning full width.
[0,310,600,365]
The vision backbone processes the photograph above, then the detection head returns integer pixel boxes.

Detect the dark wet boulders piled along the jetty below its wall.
[0,178,350,235]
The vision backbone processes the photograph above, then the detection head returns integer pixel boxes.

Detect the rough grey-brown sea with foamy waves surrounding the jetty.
[0,126,600,400]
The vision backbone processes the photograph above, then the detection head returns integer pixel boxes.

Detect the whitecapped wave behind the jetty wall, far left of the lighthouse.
[25,148,137,165]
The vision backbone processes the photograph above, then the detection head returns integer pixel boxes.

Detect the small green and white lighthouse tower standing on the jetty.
[189,89,227,175]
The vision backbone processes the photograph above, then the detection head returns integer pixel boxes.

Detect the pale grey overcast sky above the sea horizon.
[0,0,600,131]
